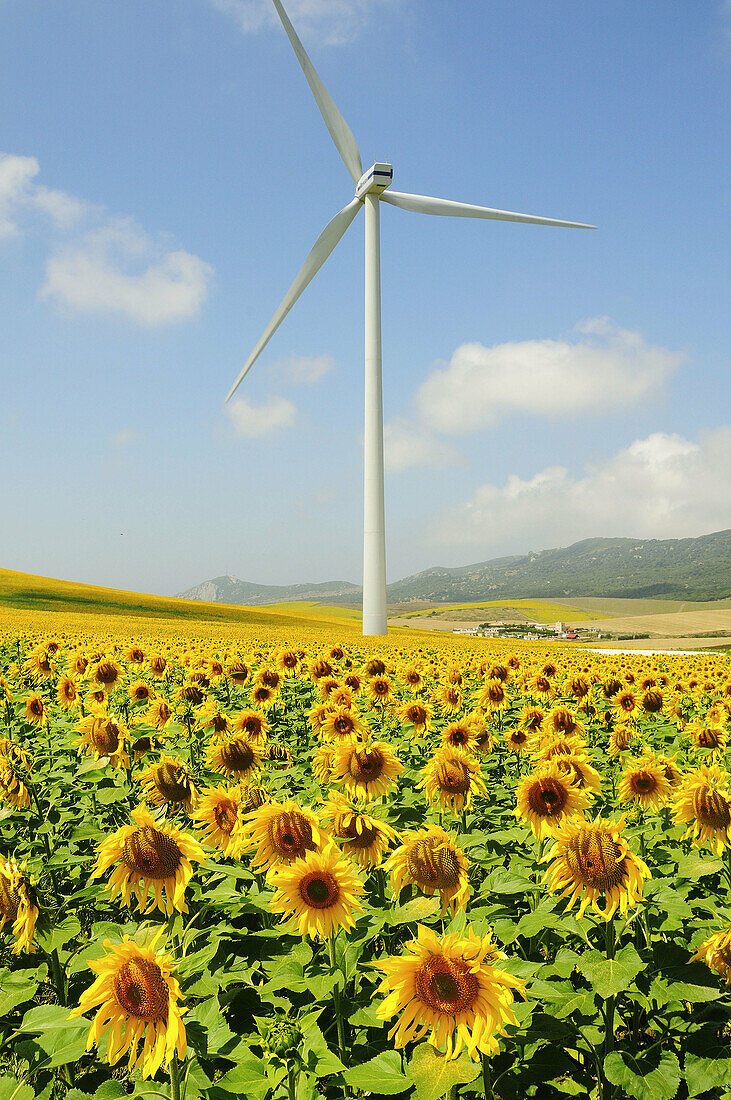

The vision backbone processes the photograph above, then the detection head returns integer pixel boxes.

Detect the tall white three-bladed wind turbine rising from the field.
[225,0,596,635]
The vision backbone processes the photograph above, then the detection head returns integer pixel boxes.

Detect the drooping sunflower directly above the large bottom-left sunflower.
[91,806,206,916]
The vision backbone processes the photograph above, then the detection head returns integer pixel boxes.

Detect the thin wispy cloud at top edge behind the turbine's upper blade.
[210,0,394,45]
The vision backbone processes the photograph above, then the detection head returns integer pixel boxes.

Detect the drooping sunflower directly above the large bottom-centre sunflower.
[386,825,469,915]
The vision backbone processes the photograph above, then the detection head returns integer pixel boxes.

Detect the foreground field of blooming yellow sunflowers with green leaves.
[0,613,731,1100]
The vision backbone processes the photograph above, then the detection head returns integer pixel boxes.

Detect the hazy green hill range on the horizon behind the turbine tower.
[180,530,731,605]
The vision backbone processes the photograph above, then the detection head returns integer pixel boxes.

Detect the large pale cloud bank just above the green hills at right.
[431,426,731,558]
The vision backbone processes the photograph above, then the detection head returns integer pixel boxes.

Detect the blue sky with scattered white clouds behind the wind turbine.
[0,0,731,593]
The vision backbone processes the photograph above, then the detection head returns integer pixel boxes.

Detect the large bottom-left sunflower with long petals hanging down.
[69,930,187,1080]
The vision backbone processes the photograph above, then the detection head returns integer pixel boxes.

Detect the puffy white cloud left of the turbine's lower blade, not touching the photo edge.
[41,219,213,327]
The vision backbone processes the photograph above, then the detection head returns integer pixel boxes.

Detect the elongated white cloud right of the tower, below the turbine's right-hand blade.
[416,318,686,435]
